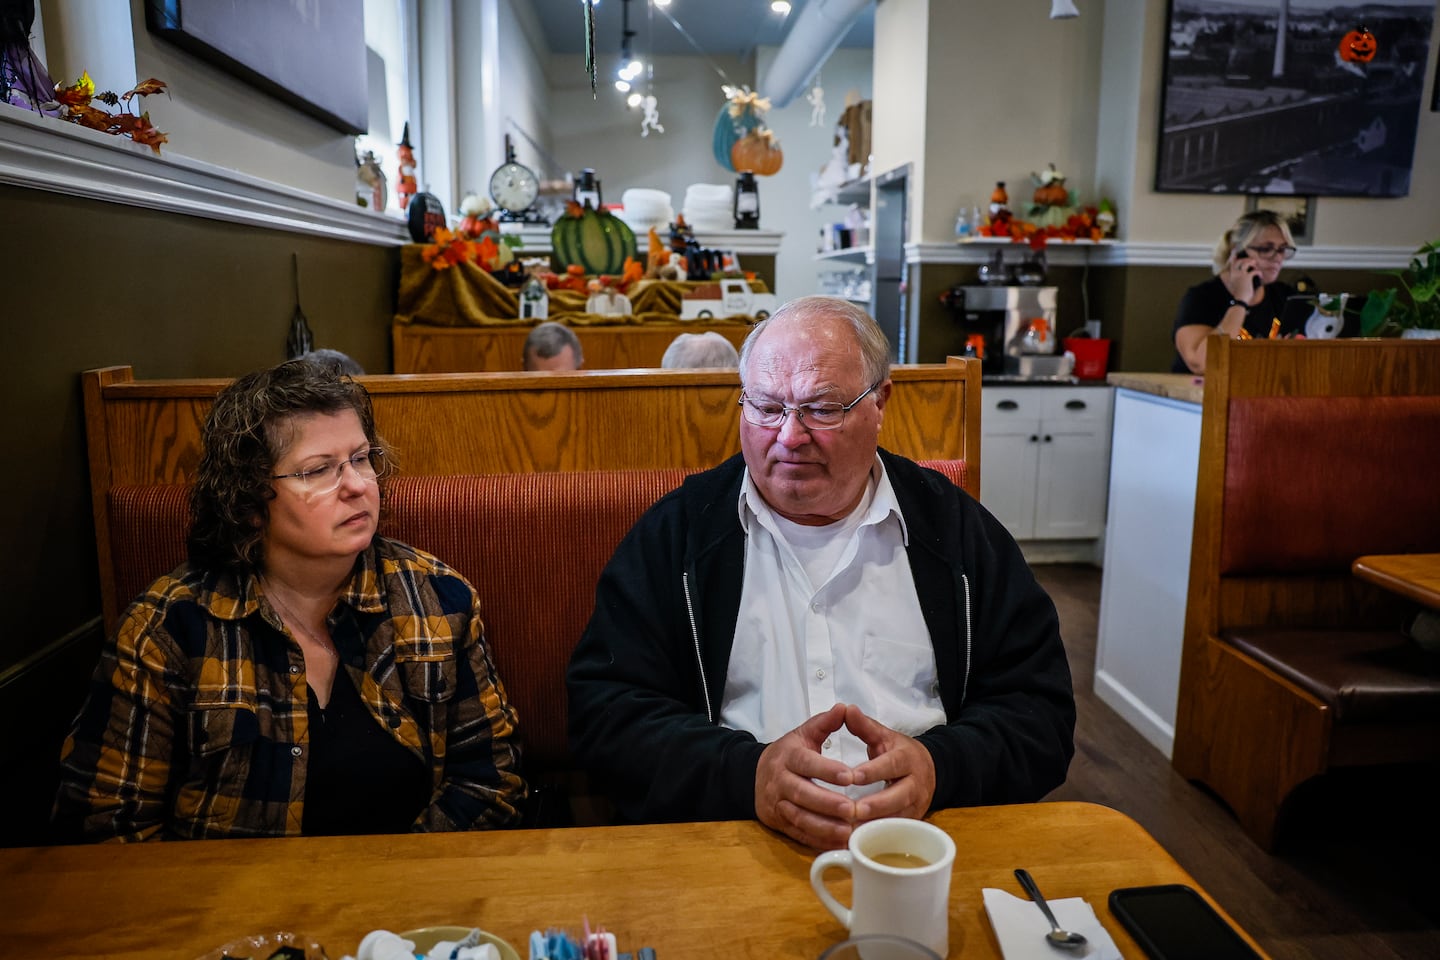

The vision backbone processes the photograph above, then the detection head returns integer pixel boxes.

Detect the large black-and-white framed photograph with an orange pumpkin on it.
[1155,0,1436,197]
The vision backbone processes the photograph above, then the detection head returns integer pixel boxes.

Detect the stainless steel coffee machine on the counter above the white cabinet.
[949,286,1060,379]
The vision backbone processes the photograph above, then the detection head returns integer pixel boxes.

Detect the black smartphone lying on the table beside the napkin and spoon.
[1110,884,1260,960]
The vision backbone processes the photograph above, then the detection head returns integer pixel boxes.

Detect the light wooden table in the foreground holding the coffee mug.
[0,803,1267,960]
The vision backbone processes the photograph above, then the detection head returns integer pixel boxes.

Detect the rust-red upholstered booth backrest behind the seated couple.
[108,461,965,822]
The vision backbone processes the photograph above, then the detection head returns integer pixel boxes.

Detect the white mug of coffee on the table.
[811,818,955,957]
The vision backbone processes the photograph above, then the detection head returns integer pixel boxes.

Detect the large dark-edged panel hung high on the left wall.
[145,0,370,134]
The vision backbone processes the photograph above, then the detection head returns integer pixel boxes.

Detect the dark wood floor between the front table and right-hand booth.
[1035,564,1440,960]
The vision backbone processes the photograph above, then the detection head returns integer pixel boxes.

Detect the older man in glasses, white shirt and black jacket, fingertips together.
[567,296,1074,848]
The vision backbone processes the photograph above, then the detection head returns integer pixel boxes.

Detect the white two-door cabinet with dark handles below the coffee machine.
[981,386,1112,540]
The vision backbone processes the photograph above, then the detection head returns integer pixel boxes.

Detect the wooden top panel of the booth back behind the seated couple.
[82,361,981,625]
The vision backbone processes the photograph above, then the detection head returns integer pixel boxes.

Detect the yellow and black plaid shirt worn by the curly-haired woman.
[55,537,527,841]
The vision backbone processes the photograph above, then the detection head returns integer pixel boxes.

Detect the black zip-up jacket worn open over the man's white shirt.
[566,450,1076,822]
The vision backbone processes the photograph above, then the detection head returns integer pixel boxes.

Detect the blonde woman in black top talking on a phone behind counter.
[1171,210,1299,374]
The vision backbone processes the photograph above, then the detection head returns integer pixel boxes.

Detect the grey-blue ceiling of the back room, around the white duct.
[521,0,876,60]
